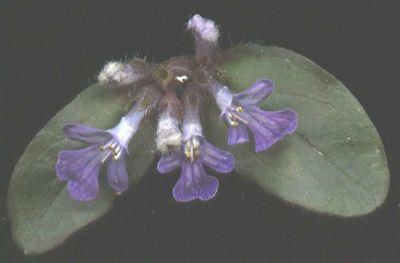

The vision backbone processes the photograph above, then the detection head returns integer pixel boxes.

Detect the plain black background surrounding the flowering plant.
[0,1,400,263]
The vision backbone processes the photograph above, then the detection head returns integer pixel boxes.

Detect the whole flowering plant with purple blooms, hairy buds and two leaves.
[8,15,389,254]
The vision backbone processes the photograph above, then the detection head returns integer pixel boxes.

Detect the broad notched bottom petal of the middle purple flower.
[173,160,218,202]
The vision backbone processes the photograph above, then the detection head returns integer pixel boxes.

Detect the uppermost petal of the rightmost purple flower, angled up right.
[235,79,274,105]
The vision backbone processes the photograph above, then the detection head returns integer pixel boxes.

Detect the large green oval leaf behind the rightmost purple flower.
[206,45,389,217]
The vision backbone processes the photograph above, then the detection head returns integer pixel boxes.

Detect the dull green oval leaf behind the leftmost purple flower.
[7,82,155,254]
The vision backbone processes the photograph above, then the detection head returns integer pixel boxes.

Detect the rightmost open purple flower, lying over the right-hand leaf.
[211,79,297,152]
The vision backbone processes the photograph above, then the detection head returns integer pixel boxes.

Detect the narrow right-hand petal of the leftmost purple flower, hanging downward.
[107,153,129,192]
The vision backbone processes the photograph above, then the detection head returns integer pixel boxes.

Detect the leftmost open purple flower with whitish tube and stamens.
[56,113,144,201]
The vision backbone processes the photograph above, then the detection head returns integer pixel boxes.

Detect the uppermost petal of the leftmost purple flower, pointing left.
[63,123,112,144]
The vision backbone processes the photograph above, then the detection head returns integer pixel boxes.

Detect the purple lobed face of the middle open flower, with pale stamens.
[157,136,235,202]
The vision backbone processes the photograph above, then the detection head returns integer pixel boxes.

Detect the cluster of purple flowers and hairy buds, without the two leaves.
[56,15,297,201]
